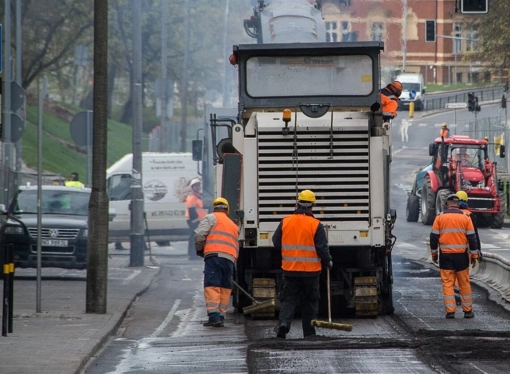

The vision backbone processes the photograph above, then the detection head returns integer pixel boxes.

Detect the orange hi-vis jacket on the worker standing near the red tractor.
[432,209,478,258]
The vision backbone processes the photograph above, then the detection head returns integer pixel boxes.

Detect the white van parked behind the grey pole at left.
[106,152,198,246]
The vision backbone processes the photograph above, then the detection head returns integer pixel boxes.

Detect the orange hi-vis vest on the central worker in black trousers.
[282,214,322,272]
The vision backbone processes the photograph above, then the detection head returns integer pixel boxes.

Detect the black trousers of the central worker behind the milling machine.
[280,274,320,338]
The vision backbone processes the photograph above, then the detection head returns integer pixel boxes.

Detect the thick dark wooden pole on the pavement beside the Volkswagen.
[85,0,109,314]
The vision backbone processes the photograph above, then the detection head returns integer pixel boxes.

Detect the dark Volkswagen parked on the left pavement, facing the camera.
[0,186,91,269]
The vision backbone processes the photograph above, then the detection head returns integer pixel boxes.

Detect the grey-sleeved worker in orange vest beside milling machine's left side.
[195,197,239,327]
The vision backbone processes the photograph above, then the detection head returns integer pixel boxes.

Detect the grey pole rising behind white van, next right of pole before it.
[159,0,168,152]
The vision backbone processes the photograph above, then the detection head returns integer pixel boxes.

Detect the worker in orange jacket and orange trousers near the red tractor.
[430,194,478,318]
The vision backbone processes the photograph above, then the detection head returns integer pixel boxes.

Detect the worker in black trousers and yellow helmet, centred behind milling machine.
[273,190,333,339]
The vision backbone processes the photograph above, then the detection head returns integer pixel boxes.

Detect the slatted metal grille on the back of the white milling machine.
[258,127,369,222]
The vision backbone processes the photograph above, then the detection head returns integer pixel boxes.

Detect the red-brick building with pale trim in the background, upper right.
[322,0,490,85]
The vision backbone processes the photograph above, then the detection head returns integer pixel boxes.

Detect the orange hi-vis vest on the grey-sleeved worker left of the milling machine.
[204,212,239,262]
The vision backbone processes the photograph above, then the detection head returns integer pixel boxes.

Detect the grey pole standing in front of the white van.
[129,0,145,266]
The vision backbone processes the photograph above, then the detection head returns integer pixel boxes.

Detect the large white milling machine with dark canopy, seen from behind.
[221,42,396,317]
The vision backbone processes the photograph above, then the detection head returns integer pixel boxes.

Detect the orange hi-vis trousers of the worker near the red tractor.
[440,267,473,313]
